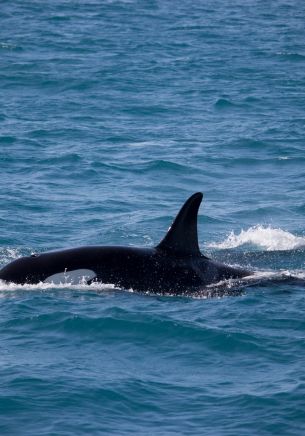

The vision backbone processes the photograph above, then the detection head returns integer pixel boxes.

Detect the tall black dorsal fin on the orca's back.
[157,192,203,256]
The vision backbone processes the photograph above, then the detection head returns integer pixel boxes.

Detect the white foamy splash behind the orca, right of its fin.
[208,225,305,251]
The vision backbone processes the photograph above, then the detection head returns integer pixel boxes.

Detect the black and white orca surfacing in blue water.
[0,192,252,294]
